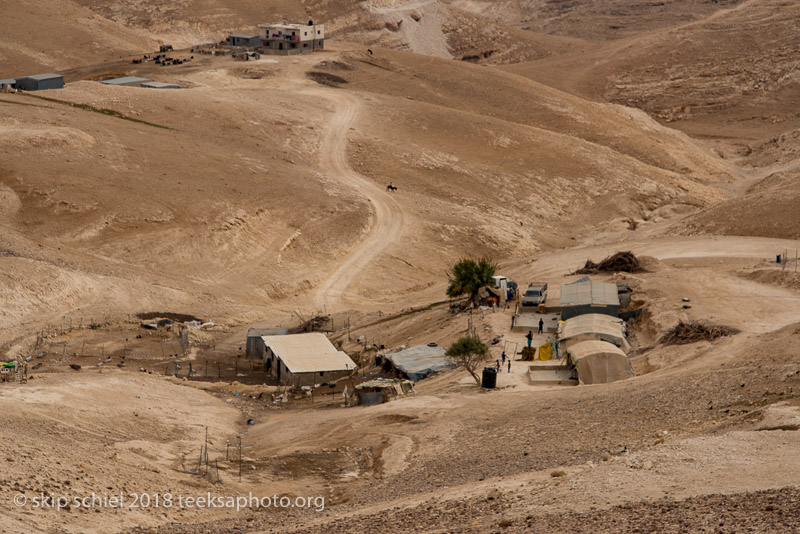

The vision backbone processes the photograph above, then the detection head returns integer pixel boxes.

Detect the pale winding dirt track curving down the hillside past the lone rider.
[304,89,404,312]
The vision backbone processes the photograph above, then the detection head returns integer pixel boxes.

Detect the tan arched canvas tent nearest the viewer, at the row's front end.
[567,341,634,384]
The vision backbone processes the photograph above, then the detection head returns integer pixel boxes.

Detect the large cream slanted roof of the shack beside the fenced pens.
[261,332,356,373]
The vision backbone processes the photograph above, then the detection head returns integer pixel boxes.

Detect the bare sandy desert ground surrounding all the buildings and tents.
[0,0,800,533]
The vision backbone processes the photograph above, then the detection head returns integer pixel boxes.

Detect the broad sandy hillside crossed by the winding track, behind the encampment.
[0,45,731,348]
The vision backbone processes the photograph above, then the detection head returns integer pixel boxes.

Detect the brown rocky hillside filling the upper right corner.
[508,0,800,144]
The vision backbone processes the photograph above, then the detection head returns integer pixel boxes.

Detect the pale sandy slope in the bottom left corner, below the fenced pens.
[0,368,240,532]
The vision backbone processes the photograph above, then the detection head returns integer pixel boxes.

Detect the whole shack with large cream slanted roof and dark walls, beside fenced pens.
[261,332,357,386]
